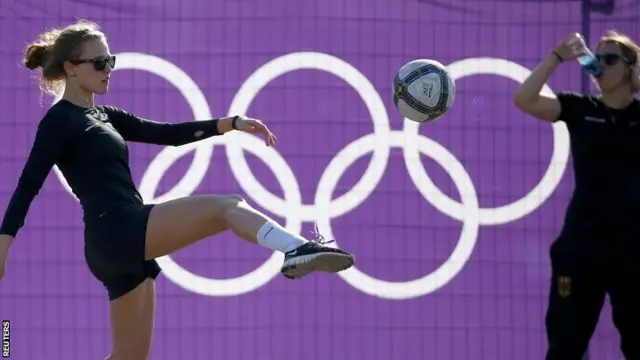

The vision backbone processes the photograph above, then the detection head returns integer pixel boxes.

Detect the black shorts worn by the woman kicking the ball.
[84,204,161,301]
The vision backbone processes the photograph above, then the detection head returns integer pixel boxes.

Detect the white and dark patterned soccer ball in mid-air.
[393,59,456,123]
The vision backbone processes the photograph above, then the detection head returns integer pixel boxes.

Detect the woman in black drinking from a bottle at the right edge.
[515,31,640,360]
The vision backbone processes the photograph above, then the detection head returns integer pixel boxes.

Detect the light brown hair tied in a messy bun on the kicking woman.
[24,20,106,95]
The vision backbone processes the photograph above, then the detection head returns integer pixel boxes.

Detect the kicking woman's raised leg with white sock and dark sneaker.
[145,195,354,279]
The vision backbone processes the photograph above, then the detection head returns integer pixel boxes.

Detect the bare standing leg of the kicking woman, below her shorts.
[107,279,155,360]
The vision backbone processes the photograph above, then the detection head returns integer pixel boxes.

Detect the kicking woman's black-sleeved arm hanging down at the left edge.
[0,114,70,237]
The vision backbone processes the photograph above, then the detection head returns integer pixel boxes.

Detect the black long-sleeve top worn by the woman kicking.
[0,100,220,236]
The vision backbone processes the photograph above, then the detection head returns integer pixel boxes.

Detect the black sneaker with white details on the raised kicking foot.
[280,227,354,279]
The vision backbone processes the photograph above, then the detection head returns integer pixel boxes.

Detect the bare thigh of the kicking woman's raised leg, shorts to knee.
[145,195,243,259]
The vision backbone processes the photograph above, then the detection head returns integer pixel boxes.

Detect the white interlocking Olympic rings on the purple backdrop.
[55,52,569,300]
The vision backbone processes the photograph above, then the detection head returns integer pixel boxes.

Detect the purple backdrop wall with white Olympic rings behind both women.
[0,0,640,360]
